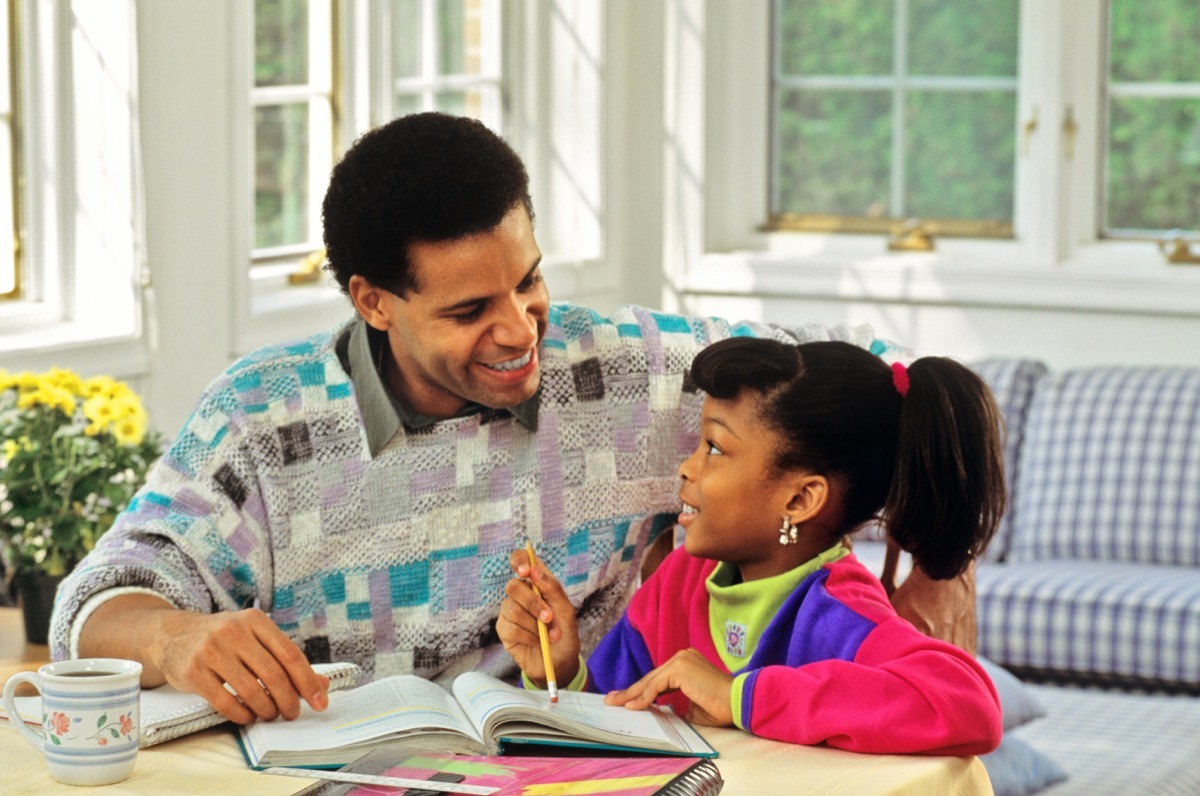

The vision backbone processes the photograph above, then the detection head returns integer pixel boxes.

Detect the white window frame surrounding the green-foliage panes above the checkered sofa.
[668,0,1200,317]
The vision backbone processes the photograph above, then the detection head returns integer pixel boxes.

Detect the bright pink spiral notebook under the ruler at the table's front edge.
[285,744,725,796]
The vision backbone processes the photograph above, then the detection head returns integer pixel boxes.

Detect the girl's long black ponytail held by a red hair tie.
[883,357,1007,580]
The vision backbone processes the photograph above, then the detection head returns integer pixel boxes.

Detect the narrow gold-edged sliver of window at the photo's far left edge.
[0,2,22,299]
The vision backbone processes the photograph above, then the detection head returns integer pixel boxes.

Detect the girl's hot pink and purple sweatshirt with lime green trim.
[586,549,1002,755]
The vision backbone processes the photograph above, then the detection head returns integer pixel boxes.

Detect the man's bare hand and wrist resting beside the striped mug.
[79,594,329,724]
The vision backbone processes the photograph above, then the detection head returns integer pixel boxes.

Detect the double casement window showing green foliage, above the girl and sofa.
[767,0,1200,252]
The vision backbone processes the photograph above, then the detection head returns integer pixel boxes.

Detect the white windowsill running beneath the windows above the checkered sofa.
[676,234,1200,317]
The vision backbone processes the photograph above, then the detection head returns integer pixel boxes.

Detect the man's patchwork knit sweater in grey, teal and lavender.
[50,304,878,678]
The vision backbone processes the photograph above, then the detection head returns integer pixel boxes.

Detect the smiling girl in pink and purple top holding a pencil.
[497,337,1004,755]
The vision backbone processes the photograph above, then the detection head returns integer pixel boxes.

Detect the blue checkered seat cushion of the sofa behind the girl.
[976,561,1200,684]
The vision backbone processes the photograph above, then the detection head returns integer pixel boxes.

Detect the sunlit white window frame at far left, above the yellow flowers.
[0,0,150,378]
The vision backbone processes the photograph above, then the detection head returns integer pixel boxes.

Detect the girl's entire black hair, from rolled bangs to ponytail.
[691,337,1007,580]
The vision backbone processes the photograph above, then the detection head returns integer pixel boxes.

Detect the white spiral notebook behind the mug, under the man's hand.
[0,663,362,749]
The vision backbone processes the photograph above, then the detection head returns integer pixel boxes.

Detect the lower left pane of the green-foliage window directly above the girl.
[774,91,892,216]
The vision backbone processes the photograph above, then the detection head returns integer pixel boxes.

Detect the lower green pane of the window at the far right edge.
[1106,97,1200,231]
